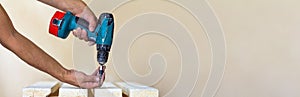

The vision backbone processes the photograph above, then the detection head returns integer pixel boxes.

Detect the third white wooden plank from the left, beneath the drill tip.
[94,82,122,97]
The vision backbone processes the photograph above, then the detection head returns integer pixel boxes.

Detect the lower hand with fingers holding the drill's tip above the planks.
[62,69,103,89]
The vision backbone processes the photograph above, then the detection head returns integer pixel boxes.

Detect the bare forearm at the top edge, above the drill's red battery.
[38,0,86,14]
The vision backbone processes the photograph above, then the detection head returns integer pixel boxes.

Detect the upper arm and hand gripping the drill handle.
[38,0,97,45]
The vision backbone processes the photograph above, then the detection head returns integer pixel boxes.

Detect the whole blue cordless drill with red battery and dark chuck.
[49,11,114,81]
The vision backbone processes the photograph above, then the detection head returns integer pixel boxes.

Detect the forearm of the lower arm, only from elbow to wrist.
[3,30,68,81]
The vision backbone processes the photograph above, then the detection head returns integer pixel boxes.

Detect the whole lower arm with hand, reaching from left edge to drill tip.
[0,4,99,88]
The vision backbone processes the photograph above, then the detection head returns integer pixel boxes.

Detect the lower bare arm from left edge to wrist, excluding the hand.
[0,4,68,81]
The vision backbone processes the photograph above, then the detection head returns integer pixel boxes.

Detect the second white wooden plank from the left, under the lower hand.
[58,83,89,97]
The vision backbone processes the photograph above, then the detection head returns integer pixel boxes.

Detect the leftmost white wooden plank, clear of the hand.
[23,81,60,97]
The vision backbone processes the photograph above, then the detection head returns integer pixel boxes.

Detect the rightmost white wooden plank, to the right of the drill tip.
[115,82,159,97]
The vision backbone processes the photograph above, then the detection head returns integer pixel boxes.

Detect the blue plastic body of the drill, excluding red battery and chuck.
[57,12,114,45]
